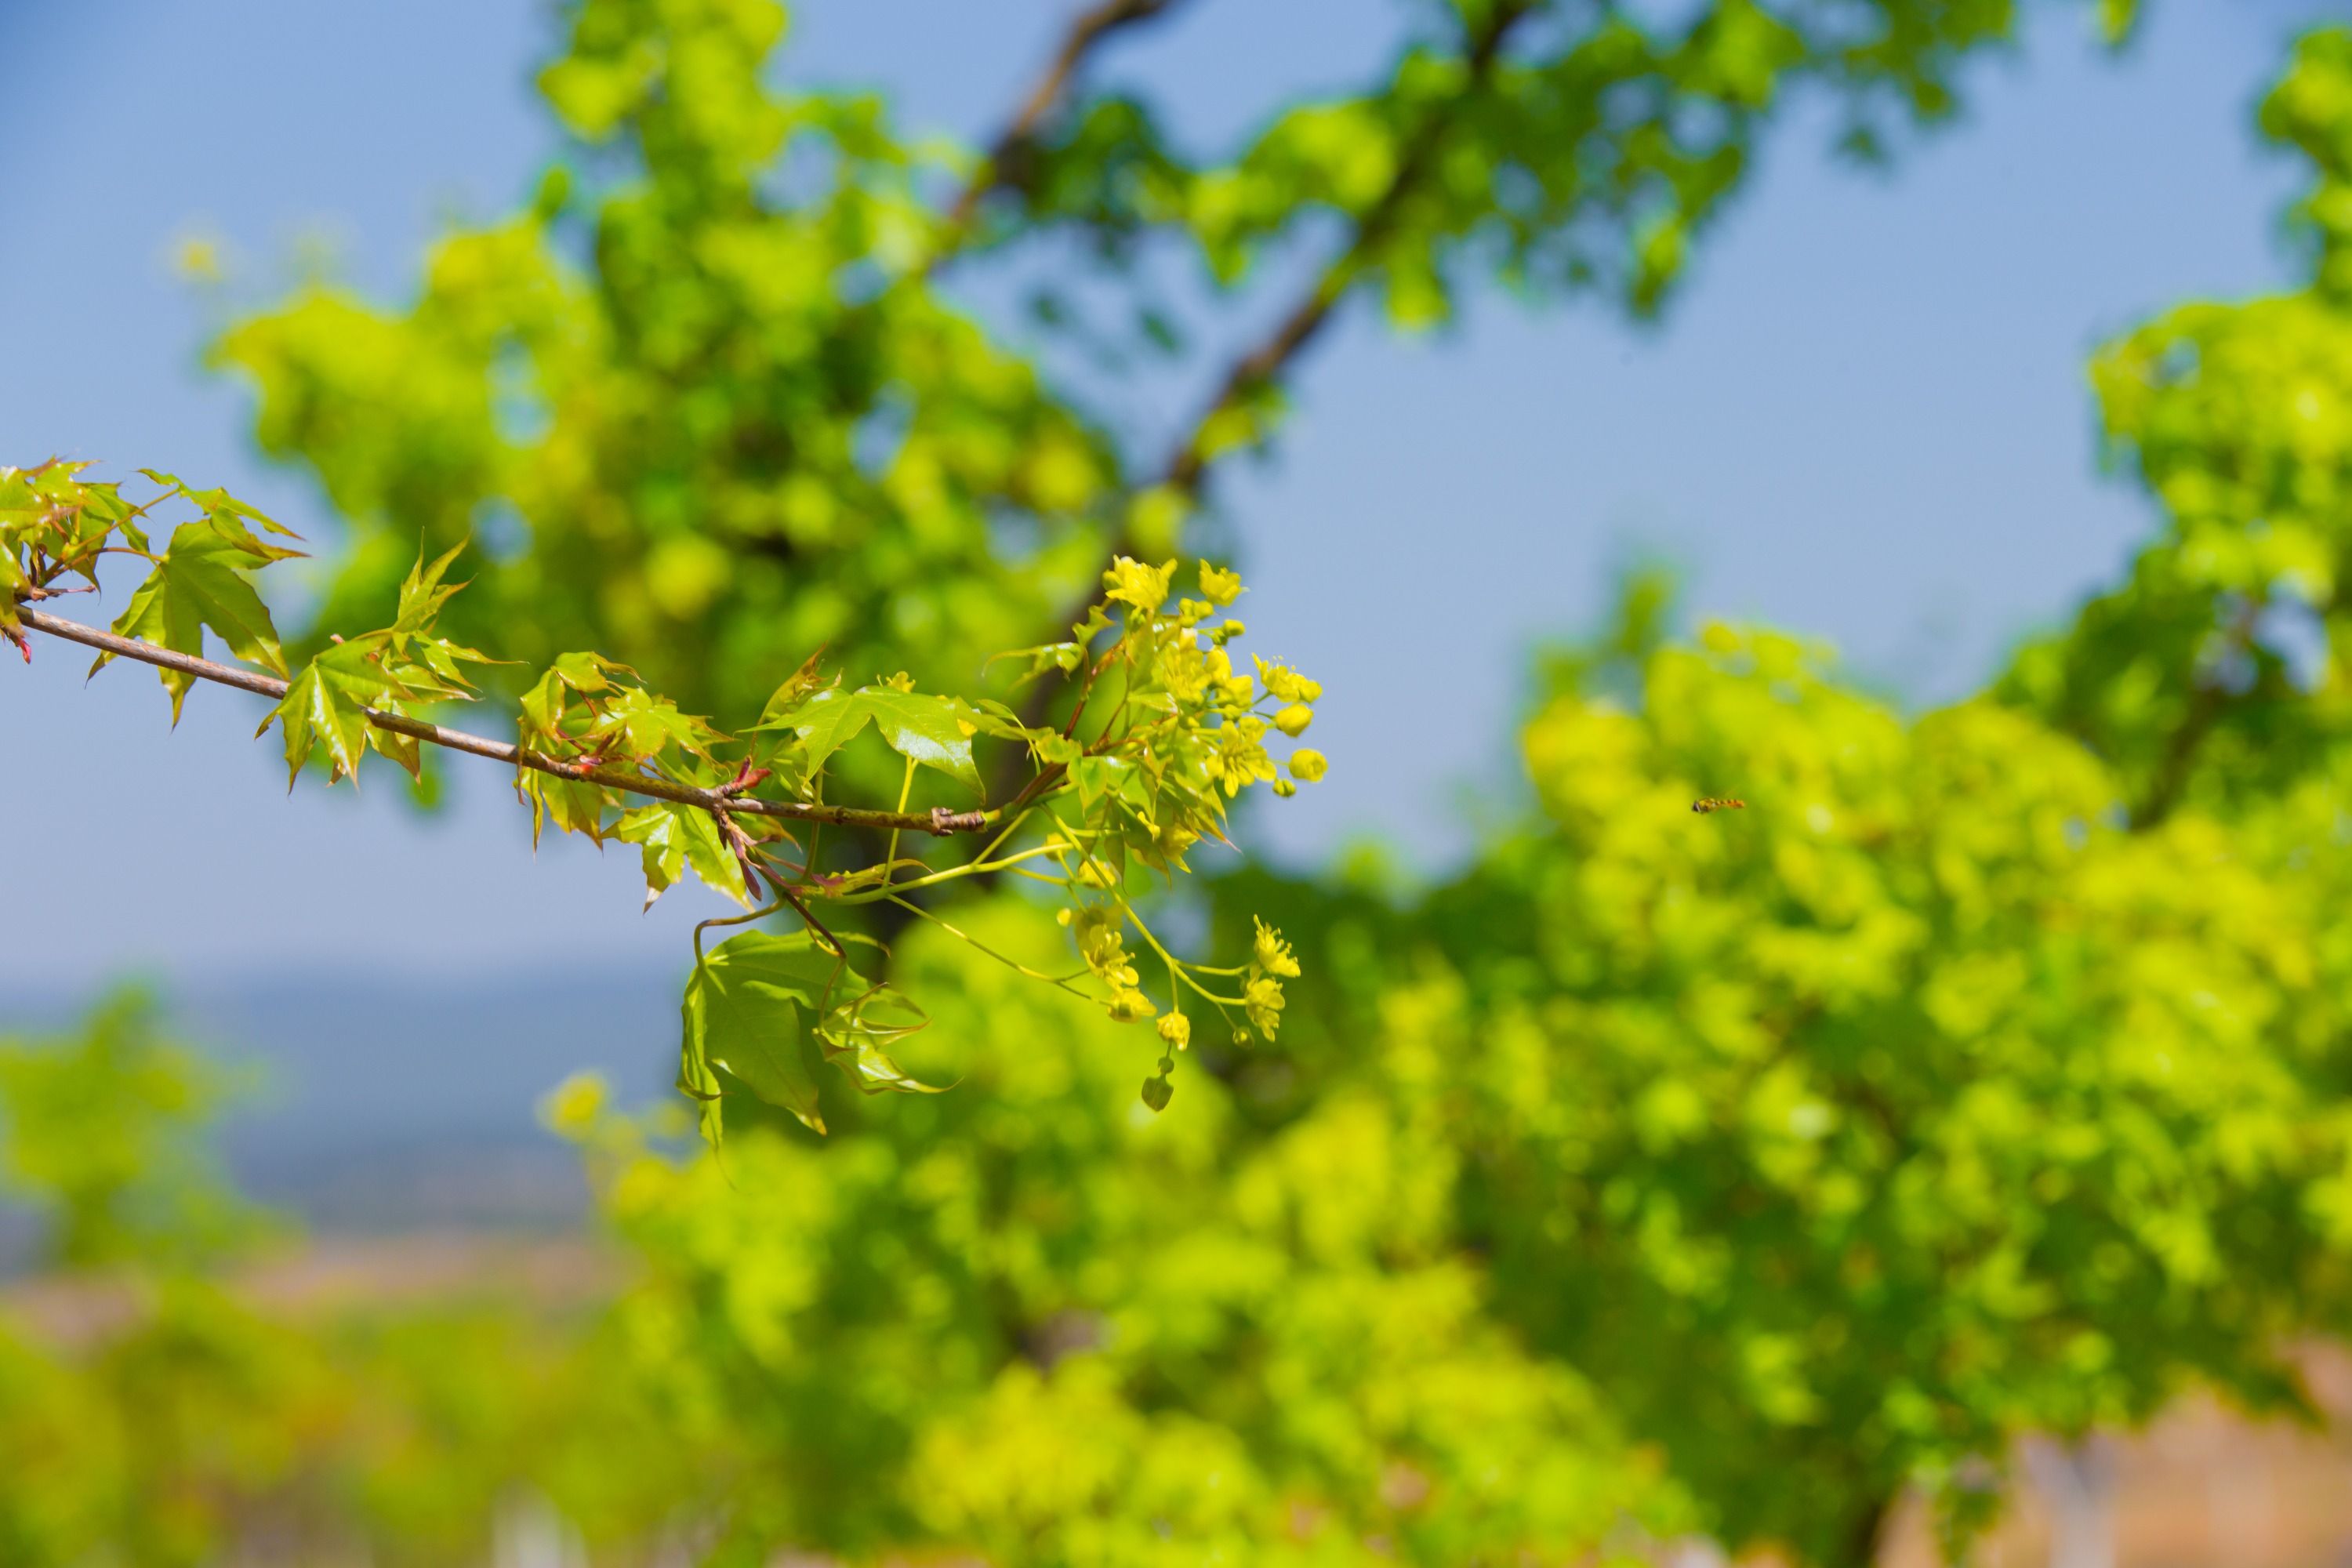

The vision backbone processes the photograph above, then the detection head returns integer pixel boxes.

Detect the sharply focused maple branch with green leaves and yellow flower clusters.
[0,463,1327,1140]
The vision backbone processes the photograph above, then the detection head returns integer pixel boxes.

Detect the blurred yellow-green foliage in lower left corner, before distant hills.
[0,992,696,1566]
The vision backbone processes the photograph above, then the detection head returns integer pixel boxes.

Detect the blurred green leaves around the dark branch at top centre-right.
[985,0,2042,340]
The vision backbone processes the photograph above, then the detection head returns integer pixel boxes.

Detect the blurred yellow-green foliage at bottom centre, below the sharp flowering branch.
[557,905,1682,1563]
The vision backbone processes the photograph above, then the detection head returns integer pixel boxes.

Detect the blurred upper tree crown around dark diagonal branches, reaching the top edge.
[216,0,2060,729]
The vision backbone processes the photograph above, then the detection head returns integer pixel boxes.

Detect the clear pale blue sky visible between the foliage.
[0,0,2312,1001]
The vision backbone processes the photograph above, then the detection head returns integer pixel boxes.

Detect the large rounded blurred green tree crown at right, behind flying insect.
[1310,628,2352,1563]
